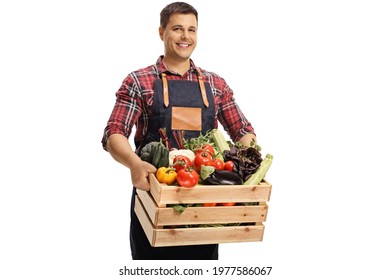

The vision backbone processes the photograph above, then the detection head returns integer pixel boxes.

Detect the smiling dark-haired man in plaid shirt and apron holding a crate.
[102,2,256,260]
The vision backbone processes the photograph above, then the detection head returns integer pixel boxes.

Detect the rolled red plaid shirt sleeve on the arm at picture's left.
[102,74,142,149]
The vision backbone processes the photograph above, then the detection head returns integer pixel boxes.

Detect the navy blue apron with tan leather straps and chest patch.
[130,72,218,260]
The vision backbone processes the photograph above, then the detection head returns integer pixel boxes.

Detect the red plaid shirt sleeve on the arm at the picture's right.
[218,78,255,142]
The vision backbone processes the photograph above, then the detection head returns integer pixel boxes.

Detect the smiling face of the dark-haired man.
[159,14,198,61]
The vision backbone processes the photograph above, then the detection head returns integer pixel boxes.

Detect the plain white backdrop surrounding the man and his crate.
[0,0,390,280]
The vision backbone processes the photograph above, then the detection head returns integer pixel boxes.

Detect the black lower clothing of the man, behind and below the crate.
[130,188,218,260]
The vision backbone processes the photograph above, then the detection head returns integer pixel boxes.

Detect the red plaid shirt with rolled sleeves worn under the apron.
[102,56,254,148]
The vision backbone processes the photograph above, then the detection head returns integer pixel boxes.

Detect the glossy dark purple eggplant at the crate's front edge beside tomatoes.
[201,165,243,185]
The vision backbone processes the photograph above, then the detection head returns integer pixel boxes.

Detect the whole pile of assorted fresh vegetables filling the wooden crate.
[140,129,273,192]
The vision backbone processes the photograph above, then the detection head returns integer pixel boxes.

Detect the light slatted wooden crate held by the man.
[135,174,272,247]
